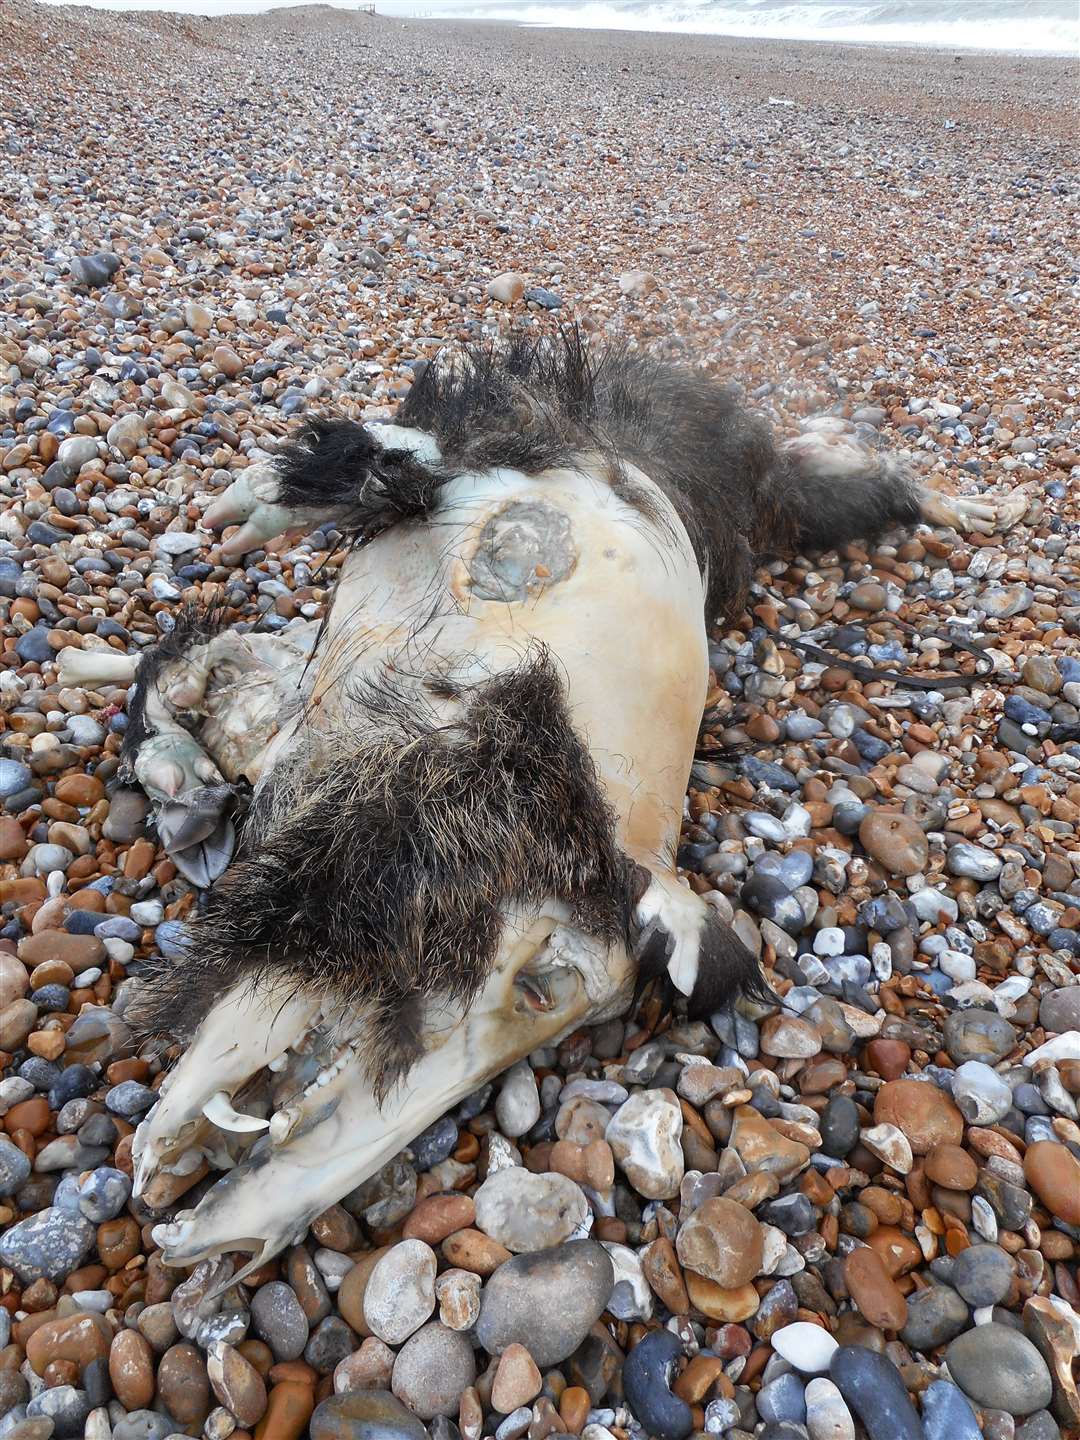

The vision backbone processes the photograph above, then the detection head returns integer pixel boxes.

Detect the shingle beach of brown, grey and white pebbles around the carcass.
[0,11,1080,1440]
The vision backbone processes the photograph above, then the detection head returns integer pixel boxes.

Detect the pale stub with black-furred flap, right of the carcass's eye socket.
[632,864,768,1018]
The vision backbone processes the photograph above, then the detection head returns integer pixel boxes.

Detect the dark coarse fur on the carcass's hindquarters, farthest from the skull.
[278,327,917,621]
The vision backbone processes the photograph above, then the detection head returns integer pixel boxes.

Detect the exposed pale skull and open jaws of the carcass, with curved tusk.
[132,903,632,1283]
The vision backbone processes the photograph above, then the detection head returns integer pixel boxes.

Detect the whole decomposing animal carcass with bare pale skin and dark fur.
[80,331,1027,1279]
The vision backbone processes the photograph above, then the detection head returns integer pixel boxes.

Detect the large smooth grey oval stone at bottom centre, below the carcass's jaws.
[475,1240,615,1369]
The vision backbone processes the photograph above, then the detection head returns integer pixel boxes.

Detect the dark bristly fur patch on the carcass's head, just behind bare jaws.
[128,647,629,1096]
